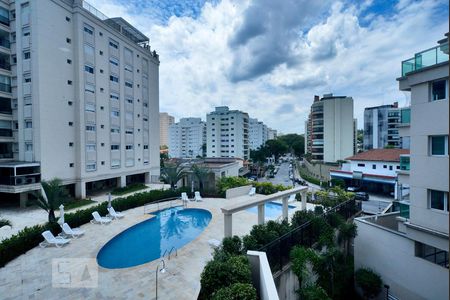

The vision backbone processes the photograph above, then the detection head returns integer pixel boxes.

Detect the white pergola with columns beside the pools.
[221,186,308,237]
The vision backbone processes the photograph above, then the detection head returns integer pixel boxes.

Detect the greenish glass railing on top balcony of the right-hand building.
[402,42,448,76]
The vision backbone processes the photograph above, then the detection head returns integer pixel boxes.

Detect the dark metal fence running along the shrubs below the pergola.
[258,199,361,273]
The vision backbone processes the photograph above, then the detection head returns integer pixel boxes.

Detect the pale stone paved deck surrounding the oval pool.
[0,198,312,300]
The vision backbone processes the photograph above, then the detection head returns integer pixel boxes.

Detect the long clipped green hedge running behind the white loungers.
[0,189,185,267]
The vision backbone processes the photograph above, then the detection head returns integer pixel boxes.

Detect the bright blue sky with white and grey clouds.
[88,0,449,133]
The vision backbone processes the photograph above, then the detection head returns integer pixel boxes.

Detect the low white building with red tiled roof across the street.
[330,149,409,195]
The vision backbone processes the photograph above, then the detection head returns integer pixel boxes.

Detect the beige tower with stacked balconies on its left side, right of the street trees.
[305,94,357,162]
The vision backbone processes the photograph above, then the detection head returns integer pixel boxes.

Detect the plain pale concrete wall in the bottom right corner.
[354,218,449,300]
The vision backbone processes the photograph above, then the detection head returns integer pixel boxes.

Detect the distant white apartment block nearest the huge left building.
[169,118,206,158]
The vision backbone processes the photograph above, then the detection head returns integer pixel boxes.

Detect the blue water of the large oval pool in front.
[97,207,212,269]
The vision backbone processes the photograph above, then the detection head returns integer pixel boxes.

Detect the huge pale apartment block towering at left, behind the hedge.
[0,0,159,204]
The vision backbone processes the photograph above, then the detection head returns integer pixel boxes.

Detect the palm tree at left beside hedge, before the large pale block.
[36,178,69,223]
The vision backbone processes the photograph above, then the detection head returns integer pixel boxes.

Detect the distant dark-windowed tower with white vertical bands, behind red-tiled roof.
[364,102,401,151]
